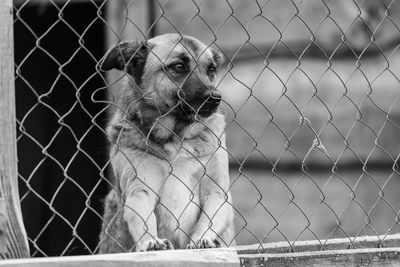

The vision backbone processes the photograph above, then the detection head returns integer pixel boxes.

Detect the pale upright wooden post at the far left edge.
[0,0,29,258]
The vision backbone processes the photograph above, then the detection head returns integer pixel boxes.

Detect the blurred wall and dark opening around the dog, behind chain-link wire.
[10,0,400,256]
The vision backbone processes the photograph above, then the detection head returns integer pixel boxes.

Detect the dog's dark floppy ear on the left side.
[100,41,149,83]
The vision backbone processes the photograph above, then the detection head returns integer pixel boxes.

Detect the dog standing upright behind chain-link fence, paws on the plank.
[99,34,234,253]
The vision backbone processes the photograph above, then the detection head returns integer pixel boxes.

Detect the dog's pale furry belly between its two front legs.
[155,160,205,247]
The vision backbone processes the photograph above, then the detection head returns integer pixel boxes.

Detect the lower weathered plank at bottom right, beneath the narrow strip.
[240,248,400,266]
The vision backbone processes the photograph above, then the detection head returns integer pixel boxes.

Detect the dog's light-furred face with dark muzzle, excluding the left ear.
[141,34,221,117]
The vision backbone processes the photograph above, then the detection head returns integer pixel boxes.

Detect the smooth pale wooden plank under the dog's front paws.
[0,248,240,267]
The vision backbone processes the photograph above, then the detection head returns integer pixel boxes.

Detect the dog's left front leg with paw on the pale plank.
[113,150,173,251]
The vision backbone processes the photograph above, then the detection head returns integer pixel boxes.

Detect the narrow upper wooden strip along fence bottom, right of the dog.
[236,234,400,254]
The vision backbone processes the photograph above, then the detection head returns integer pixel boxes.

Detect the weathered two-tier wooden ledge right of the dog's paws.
[237,234,400,266]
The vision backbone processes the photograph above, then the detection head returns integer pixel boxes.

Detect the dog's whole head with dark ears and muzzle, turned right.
[100,34,223,121]
